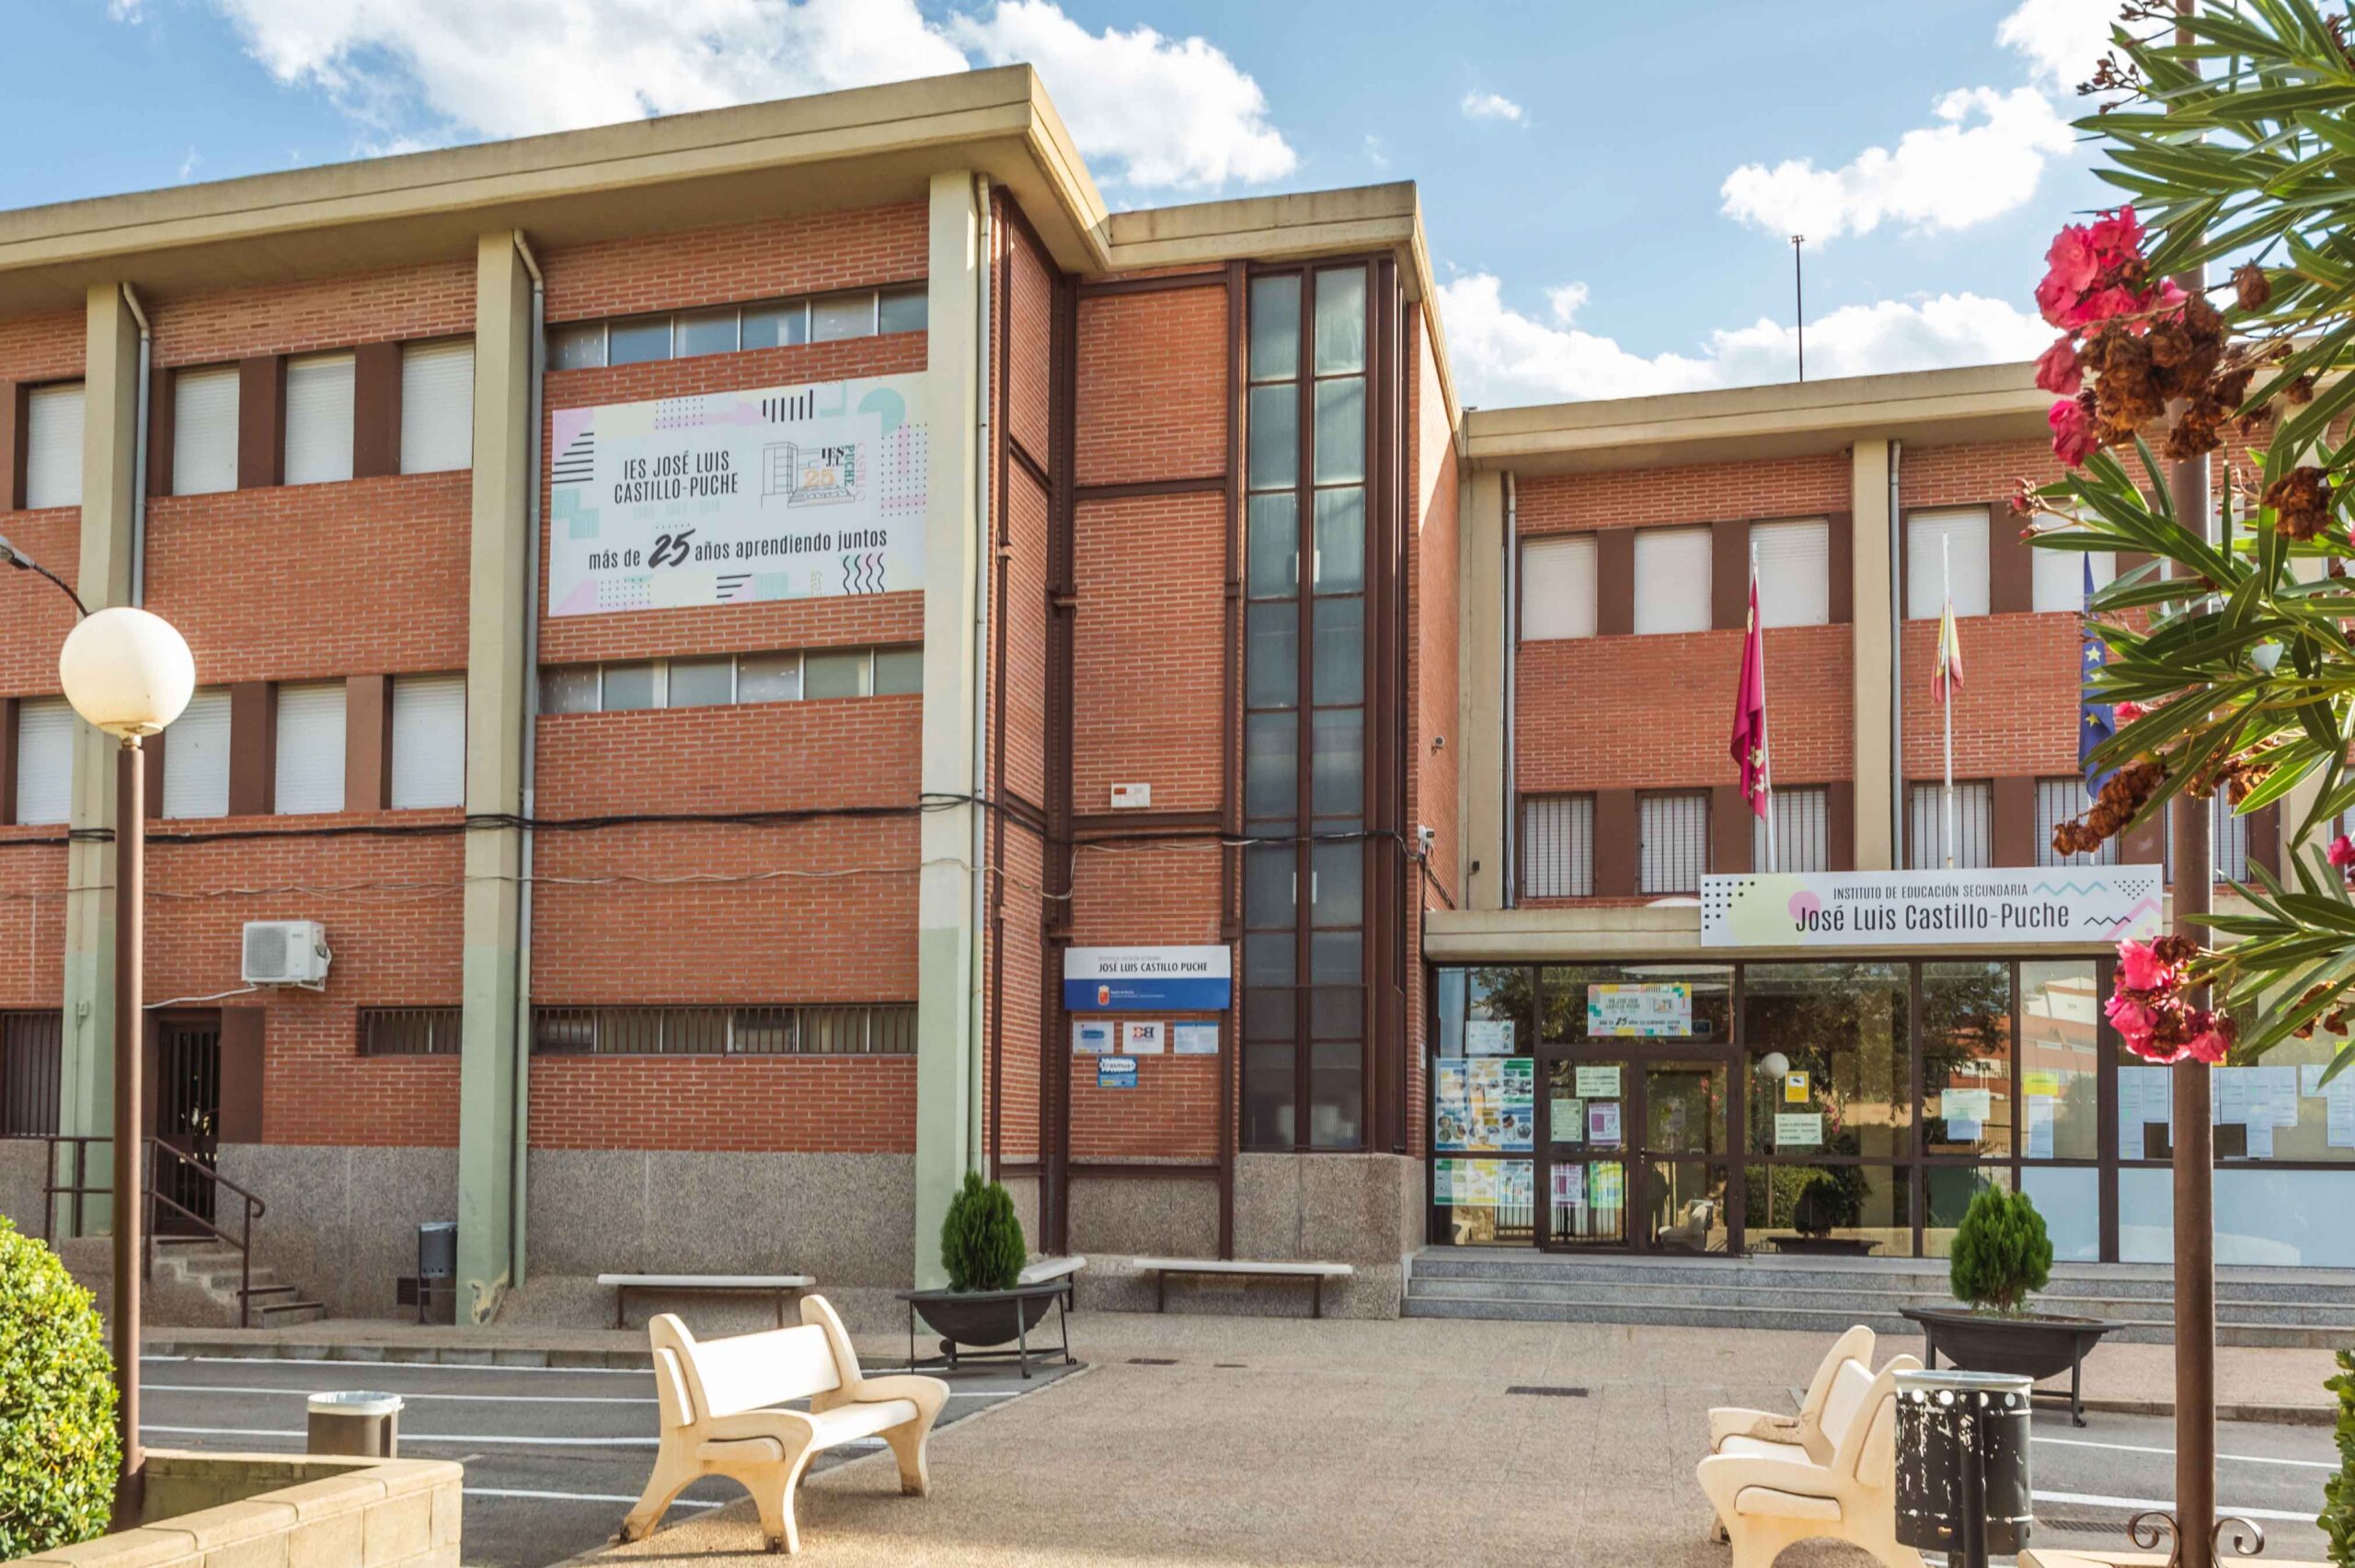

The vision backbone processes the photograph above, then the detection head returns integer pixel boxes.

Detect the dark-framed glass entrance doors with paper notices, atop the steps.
[1535,1047,1742,1255]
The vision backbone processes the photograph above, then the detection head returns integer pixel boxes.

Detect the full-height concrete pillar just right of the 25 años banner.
[913,172,982,1286]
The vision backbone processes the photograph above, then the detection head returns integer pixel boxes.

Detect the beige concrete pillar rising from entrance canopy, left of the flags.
[1455,471,1512,909]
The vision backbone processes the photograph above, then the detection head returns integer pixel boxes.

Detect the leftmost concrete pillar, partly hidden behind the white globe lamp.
[58,282,139,1231]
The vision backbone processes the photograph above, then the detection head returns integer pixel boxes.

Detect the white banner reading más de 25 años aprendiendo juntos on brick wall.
[548,374,925,614]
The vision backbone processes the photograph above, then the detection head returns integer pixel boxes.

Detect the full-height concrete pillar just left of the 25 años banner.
[457,228,537,1323]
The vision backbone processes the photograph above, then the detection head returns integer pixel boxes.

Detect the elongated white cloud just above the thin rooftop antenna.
[1719,87,2074,243]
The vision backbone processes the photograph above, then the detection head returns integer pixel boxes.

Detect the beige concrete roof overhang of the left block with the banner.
[0,66,1107,313]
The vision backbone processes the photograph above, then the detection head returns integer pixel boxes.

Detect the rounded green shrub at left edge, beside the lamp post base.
[0,1215,122,1561]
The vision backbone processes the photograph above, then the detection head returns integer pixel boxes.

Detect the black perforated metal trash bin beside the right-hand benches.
[1896,1368,2035,1568]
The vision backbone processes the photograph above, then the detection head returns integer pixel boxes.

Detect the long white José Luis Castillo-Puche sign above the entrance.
[1700,866,2160,946]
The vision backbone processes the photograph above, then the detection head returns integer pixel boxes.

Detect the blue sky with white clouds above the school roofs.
[0,0,2117,407]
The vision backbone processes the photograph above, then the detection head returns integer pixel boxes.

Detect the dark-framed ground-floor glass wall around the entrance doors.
[1427,958,2355,1266]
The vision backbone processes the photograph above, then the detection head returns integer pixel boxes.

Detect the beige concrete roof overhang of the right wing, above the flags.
[1465,365,2051,475]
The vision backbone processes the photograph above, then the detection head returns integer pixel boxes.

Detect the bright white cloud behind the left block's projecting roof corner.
[947,0,1300,189]
